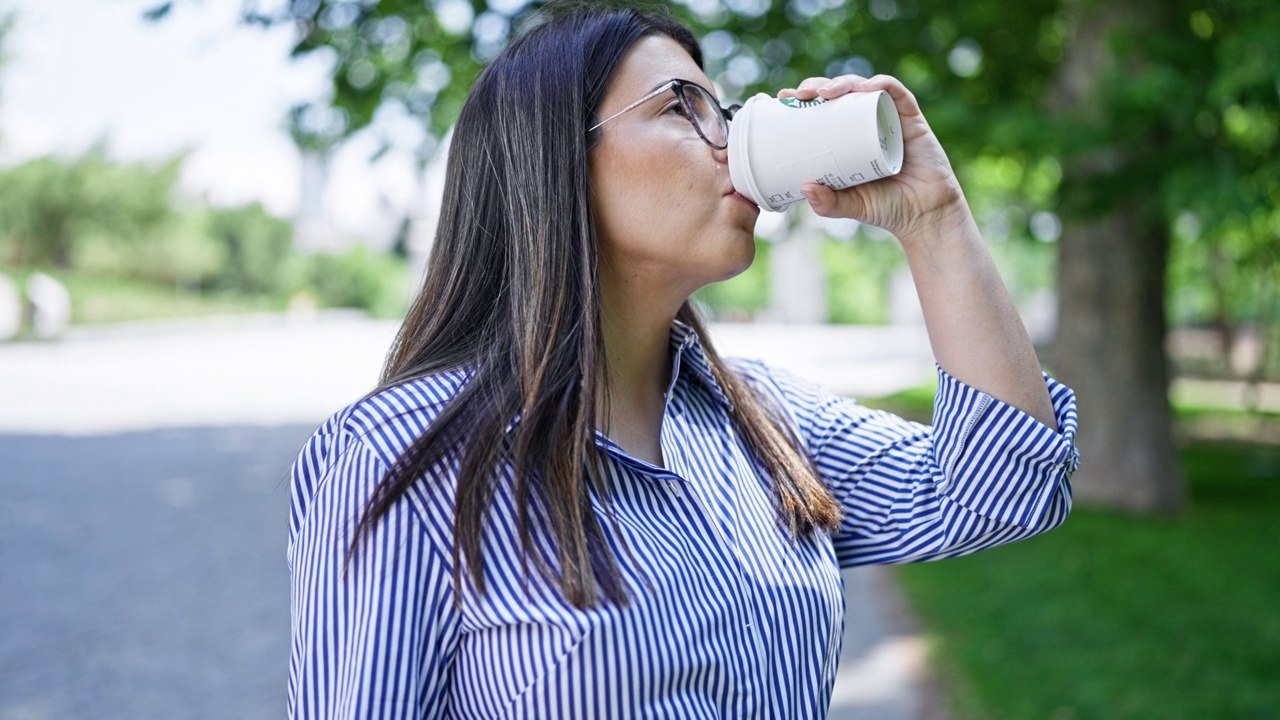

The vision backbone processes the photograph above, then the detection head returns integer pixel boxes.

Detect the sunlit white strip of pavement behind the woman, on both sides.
[0,313,933,434]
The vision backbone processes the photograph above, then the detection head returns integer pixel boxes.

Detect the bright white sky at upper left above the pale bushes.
[0,0,413,238]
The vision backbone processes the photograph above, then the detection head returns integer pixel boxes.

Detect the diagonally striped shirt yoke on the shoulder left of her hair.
[316,369,470,466]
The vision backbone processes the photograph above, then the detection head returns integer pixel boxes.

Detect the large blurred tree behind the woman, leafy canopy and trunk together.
[148,0,1280,511]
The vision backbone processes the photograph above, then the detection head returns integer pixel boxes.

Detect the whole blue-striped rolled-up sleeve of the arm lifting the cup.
[742,363,1079,566]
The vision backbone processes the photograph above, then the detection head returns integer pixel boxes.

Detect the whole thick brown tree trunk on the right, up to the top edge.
[1050,0,1185,512]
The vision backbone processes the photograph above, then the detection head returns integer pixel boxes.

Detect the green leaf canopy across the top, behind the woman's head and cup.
[154,0,1280,338]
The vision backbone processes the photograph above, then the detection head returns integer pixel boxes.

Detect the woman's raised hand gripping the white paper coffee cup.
[778,76,969,242]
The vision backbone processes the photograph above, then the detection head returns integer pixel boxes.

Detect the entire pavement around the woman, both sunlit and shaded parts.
[0,314,931,720]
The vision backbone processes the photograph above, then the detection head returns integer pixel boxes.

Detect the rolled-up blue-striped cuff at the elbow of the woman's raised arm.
[933,366,1079,528]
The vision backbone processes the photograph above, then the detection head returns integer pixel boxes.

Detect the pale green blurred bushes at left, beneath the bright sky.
[0,139,408,322]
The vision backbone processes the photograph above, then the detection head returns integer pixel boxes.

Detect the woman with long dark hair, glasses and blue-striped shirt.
[289,2,1075,719]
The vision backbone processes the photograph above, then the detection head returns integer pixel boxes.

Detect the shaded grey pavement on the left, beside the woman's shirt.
[0,425,304,720]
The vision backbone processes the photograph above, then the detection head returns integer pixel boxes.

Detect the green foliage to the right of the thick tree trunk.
[1110,1,1280,338]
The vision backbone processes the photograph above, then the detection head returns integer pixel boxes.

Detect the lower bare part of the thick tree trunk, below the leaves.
[1052,209,1184,512]
